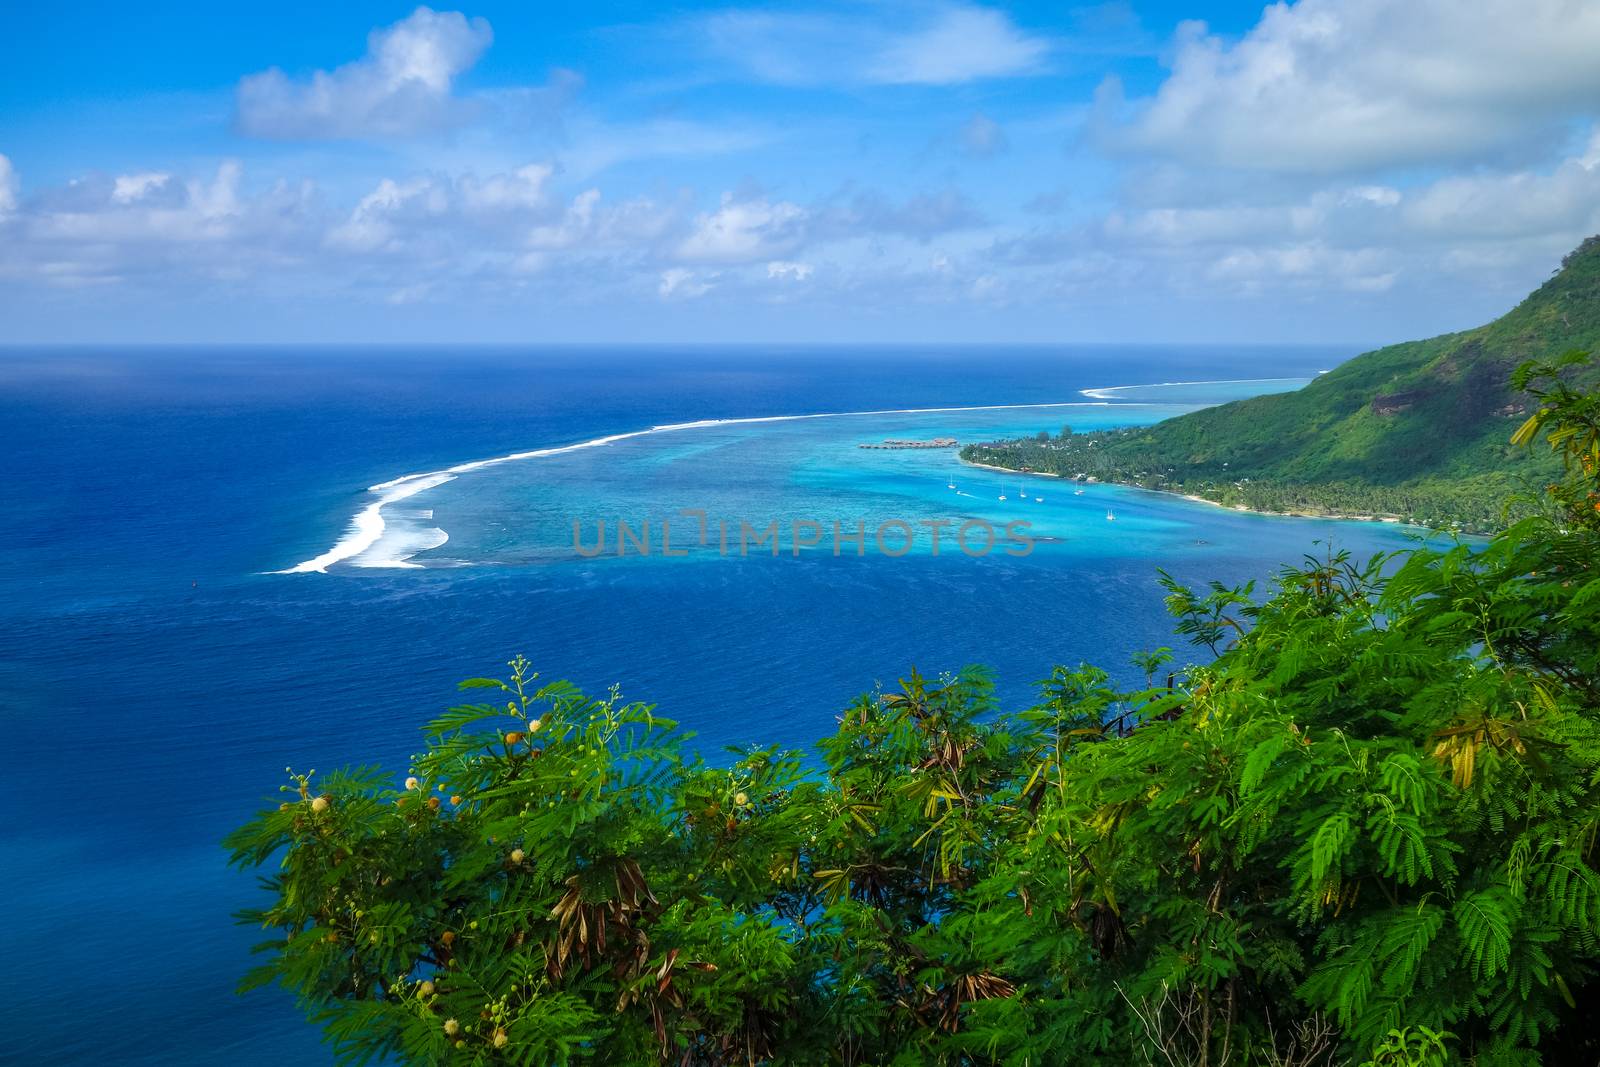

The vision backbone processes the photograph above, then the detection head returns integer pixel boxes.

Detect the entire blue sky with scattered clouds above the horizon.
[0,0,1600,344]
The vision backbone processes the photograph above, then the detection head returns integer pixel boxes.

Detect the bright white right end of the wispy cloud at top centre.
[867,6,1050,85]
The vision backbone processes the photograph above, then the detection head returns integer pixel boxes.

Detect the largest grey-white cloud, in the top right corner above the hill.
[1101,0,1600,173]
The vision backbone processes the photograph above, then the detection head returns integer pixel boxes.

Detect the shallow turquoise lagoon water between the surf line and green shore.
[331,379,1331,569]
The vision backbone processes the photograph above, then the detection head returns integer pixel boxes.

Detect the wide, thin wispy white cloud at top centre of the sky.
[686,3,1051,86]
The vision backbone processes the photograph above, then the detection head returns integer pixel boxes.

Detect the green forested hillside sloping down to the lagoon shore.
[962,237,1600,530]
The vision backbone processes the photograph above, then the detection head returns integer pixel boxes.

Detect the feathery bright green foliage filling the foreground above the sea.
[227,356,1600,1067]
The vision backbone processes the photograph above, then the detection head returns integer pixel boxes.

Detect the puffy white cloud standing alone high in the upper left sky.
[237,6,494,139]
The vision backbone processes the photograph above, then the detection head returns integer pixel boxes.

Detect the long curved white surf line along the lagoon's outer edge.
[270,398,1113,574]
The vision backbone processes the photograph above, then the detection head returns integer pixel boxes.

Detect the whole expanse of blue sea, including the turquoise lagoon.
[0,346,1411,1067]
